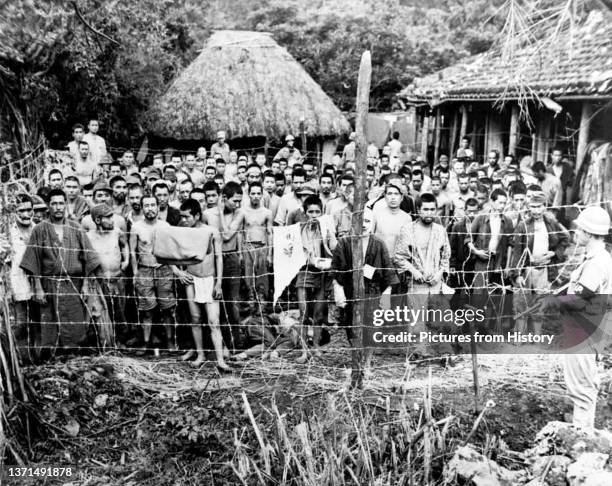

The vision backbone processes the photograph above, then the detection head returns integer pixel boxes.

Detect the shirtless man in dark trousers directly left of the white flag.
[240,182,272,315]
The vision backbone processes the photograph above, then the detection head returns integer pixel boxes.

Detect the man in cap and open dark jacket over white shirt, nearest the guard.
[510,191,569,332]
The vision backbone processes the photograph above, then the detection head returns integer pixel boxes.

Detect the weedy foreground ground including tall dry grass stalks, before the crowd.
[5,350,584,486]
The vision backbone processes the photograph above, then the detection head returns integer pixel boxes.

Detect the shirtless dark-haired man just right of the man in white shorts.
[202,181,243,349]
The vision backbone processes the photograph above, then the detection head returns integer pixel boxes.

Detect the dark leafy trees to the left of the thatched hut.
[0,0,206,150]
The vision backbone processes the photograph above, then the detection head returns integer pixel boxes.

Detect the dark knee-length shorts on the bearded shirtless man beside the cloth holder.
[134,265,176,311]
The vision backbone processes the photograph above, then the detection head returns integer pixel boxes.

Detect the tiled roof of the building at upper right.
[399,11,612,104]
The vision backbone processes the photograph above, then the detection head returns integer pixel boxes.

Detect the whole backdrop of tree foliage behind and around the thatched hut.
[0,0,499,151]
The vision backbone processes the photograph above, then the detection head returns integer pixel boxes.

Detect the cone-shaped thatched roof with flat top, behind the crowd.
[146,30,350,140]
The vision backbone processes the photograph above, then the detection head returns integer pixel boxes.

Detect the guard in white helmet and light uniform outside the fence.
[561,206,612,430]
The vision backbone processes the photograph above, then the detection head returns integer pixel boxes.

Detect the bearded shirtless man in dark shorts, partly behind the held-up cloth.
[130,196,176,354]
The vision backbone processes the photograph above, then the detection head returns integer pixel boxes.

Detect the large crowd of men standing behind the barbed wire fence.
[2,120,608,388]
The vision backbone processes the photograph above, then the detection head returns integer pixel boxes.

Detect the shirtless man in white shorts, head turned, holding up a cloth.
[178,199,231,372]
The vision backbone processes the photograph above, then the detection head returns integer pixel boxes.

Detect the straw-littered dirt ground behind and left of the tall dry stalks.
[6,338,612,485]
